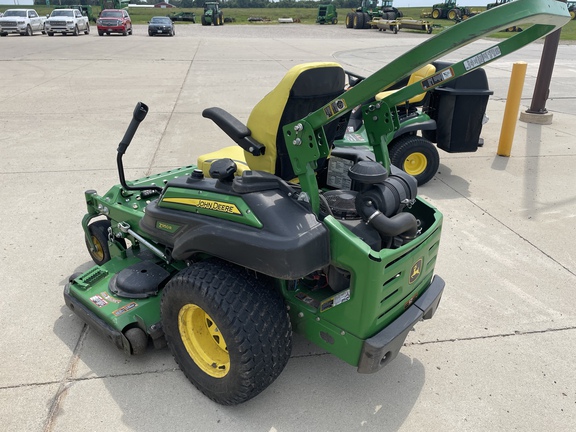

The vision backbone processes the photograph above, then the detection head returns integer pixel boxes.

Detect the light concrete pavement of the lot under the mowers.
[0,25,576,432]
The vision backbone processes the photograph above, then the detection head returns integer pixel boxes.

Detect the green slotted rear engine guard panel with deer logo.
[284,199,442,366]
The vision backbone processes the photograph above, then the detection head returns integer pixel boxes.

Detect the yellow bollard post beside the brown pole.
[497,62,528,157]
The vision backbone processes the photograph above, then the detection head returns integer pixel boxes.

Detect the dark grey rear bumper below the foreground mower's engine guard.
[358,276,445,373]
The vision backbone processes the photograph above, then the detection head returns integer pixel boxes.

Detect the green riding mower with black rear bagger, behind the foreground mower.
[334,61,493,186]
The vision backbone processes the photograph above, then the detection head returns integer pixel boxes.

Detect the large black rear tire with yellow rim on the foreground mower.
[161,259,292,405]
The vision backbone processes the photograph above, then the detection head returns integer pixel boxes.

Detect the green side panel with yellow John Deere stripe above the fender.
[158,187,262,228]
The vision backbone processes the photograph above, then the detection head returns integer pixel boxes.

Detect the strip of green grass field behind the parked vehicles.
[0,6,576,41]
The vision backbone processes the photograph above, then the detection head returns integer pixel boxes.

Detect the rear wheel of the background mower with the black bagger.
[388,135,440,186]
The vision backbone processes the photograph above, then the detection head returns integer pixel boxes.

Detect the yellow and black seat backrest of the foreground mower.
[244,62,345,180]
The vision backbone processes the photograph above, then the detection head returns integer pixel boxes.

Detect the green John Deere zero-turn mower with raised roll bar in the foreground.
[64,0,569,405]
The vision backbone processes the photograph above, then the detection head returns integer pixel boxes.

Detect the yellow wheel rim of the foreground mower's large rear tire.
[178,304,230,378]
